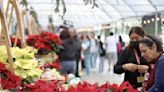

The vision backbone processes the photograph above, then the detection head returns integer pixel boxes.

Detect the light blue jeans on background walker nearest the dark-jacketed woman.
[84,54,91,76]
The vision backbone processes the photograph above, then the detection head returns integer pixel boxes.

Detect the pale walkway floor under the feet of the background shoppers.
[81,59,124,85]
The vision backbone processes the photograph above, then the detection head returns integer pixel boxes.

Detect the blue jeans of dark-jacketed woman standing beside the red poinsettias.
[60,61,76,75]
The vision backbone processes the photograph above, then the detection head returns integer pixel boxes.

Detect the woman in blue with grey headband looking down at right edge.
[139,36,164,92]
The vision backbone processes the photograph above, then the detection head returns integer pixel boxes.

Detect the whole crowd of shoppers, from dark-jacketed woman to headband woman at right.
[43,26,164,92]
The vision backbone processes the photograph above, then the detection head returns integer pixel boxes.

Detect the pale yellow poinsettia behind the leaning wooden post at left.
[0,46,42,85]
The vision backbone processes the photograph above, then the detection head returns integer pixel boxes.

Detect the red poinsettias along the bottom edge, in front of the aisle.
[67,82,138,92]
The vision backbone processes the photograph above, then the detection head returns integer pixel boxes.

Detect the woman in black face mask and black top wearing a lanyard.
[114,27,148,89]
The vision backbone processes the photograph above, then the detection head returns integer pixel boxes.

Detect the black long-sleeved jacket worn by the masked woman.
[114,47,148,88]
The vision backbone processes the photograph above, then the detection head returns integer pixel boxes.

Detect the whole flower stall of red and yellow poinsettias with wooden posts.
[0,0,138,92]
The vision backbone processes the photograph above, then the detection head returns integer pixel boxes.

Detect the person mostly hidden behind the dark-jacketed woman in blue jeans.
[70,28,81,77]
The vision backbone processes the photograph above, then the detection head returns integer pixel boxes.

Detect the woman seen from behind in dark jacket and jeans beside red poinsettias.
[59,29,77,75]
